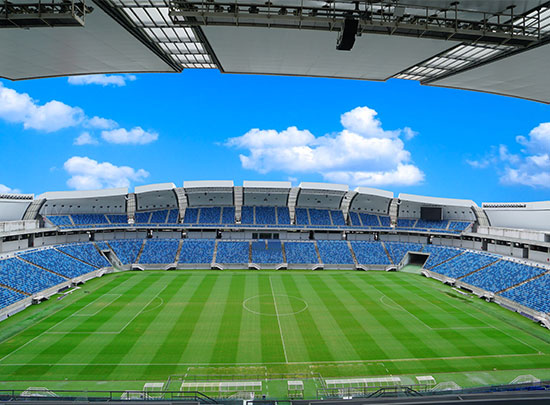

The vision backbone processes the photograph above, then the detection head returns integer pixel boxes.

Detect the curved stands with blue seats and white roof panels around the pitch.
[0,181,550,326]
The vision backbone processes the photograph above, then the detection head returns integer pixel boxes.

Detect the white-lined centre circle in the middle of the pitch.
[243,294,308,316]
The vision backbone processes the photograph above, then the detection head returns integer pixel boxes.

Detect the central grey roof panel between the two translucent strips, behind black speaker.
[203,26,457,80]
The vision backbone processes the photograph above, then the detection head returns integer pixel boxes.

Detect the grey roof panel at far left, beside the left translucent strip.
[0,3,174,80]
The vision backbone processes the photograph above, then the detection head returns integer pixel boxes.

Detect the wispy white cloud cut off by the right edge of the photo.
[468,122,550,188]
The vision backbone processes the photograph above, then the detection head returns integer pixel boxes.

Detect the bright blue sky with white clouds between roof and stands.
[0,70,550,203]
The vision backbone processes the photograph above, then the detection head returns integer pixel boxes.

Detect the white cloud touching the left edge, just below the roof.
[0,83,85,132]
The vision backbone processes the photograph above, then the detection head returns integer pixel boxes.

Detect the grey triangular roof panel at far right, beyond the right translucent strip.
[430,41,550,103]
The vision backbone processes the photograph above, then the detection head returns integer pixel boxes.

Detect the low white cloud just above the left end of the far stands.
[63,156,149,190]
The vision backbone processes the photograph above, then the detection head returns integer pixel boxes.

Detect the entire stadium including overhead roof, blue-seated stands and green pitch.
[0,0,550,405]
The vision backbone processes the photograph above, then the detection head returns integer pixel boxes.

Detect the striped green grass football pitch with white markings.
[0,271,550,395]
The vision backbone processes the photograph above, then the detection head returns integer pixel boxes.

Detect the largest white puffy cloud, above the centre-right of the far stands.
[225,107,424,185]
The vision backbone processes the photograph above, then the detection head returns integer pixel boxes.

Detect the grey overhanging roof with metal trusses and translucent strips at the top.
[0,0,550,103]
